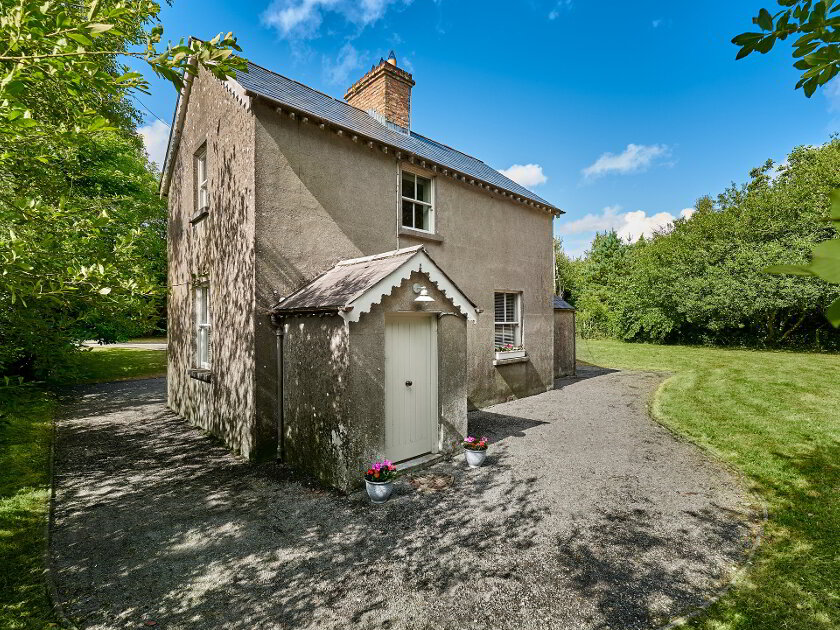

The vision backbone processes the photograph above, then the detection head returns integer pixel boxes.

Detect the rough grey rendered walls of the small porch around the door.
[283,274,467,490]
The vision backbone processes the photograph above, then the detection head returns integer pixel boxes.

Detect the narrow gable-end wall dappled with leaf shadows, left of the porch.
[167,70,259,458]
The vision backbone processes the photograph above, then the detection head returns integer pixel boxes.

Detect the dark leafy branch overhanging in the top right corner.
[732,0,840,98]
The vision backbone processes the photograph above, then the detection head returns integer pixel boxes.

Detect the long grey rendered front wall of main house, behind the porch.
[254,103,554,427]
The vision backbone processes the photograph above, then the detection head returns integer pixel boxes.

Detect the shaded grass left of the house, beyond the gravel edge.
[0,349,166,630]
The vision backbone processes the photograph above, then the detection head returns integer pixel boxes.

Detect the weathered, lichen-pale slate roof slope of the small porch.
[275,245,423,312]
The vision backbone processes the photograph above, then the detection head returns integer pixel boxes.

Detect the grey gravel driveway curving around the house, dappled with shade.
[51,369,755,630]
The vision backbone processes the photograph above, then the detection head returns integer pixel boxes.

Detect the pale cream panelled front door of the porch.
[385,313,438,462]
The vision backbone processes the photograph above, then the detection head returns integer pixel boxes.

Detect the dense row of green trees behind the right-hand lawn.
[555,136,840,349]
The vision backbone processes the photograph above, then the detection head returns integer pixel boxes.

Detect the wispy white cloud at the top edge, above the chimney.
[262,0,412,39]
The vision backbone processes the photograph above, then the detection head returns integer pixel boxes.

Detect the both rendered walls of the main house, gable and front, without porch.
[169,70,553,472]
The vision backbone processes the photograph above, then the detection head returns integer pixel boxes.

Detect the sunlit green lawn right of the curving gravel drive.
[578,340,840,630]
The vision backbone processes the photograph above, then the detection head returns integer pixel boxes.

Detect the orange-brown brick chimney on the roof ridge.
[344,50,414,130]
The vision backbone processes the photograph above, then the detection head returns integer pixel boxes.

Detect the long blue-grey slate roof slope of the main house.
[236,62,562,212]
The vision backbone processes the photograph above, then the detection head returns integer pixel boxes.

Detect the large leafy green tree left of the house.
[0,0,243,378]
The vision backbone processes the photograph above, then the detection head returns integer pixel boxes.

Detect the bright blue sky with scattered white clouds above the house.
[138,0,840,256]
